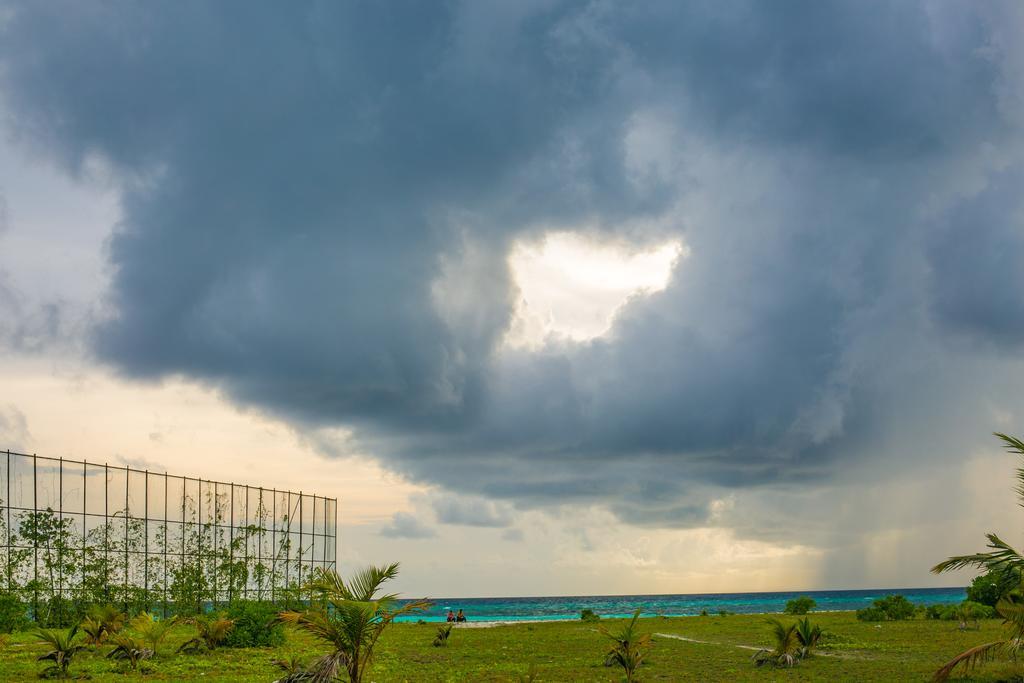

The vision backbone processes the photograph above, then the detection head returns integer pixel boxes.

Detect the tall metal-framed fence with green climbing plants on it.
[0,451,338,617]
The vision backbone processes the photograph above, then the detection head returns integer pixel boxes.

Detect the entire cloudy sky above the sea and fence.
[0,0,1024,597]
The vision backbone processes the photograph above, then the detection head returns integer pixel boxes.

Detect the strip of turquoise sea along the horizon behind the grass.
[399,588,965,622]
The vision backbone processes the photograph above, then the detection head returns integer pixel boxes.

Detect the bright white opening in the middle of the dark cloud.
[505,232,688,348]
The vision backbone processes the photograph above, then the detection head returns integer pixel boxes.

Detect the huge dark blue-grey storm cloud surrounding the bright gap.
[0,2,1024,533]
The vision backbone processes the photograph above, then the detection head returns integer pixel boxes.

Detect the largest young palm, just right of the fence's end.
[280,563,430,683]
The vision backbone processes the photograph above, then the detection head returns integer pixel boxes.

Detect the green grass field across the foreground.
[0,612,1017,682]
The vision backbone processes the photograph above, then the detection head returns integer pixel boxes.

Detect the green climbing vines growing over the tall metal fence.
[0,458,333,630]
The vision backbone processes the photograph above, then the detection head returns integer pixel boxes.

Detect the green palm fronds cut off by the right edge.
[932,433,1024,681]
